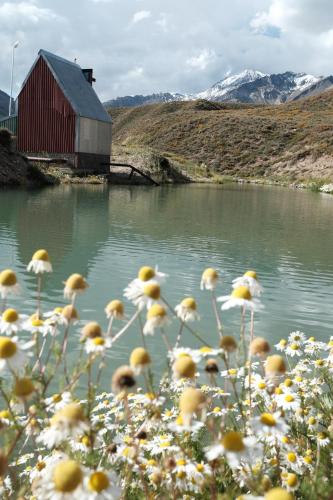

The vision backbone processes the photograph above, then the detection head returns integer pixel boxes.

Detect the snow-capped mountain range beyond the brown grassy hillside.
[105,69,333,107]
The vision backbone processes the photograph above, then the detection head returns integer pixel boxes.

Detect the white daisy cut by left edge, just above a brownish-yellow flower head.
[0,337,34,374]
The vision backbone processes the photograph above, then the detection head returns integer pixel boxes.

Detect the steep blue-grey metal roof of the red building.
[23,49,111,122]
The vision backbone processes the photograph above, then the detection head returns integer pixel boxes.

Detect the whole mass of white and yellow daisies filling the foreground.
[0,250,333,500]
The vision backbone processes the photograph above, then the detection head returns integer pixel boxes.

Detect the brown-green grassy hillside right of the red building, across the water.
[110,91,333,180]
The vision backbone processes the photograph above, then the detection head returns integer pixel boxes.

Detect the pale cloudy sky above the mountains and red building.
[0,0,333,100]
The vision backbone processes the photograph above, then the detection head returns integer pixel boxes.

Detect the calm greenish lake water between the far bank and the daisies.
[0,185,333,384]
